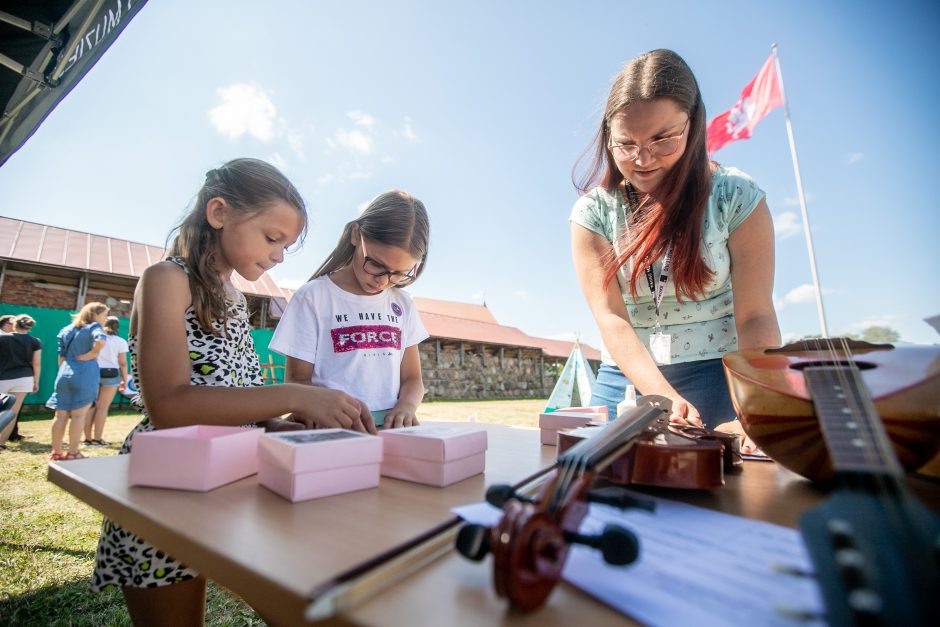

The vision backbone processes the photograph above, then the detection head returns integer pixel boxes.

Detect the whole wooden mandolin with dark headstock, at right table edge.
[725,340,940,627]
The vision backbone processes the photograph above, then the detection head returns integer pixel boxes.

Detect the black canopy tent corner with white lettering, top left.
[0,0,147,166]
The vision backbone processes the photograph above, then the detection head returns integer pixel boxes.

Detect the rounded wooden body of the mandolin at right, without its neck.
[723,340,940,480]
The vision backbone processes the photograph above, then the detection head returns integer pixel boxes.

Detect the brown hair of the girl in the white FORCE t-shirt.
[310,189,431,281]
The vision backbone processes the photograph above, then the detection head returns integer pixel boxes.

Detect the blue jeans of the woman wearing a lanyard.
[591,359,735,428]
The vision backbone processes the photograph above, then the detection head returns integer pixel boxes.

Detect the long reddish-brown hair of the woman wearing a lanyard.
[572,49,714,300]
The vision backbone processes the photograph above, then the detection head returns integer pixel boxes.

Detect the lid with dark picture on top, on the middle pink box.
[258,429,382,473]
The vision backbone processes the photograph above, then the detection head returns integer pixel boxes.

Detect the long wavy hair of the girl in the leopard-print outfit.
[169,159,307,335]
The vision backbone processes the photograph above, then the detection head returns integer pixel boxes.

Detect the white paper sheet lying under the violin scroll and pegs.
[453,495,825,627]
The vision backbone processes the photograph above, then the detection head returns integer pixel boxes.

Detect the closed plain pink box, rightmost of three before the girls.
[379,425,486,487]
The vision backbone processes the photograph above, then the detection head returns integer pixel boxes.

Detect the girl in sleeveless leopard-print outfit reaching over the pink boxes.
[91,159,375,625]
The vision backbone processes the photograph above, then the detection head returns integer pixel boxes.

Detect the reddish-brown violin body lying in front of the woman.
[558,425,741,490]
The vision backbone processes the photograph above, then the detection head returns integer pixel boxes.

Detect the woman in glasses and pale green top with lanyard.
[570,50,780,426]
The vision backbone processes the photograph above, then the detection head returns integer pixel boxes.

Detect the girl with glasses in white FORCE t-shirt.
[270,190,429,428]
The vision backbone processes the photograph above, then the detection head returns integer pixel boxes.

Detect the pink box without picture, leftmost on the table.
[128,425,264,492]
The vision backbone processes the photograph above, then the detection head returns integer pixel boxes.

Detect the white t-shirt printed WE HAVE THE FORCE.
[269,276,428,411]
